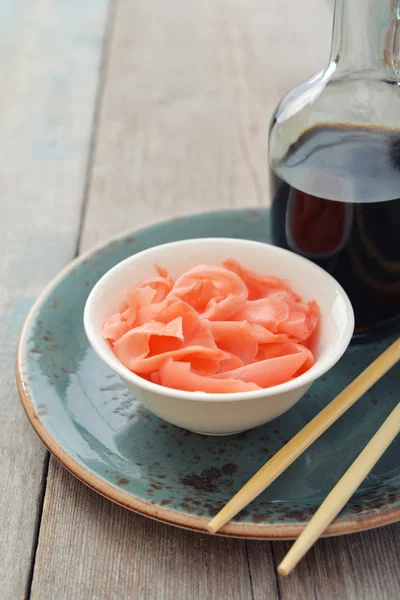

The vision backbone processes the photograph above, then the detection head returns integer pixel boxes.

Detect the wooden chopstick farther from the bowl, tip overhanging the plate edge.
[278,403,400,575]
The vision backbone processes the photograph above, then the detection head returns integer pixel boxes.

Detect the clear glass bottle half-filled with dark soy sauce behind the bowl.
[269,0,400,336]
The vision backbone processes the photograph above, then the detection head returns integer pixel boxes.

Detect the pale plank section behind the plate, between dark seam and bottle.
[82,0,332,249]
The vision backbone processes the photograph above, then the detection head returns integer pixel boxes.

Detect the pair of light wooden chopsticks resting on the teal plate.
[207,338,400,575]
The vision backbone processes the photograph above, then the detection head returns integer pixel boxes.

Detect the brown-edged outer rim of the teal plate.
[16,207,400,540]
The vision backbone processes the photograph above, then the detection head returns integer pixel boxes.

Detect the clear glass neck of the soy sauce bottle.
[331,0,400,80]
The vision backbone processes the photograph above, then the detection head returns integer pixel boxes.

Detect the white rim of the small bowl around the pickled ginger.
[83,237,354,402]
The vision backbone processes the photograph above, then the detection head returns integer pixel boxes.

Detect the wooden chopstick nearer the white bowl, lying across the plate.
[207,338,400,533]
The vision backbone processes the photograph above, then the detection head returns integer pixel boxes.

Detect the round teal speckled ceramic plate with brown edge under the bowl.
[17,210,400,539]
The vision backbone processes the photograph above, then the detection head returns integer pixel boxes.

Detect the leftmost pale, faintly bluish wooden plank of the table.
[0,0,111,599]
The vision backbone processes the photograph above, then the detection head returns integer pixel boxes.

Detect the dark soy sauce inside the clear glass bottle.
[270,125,400,335]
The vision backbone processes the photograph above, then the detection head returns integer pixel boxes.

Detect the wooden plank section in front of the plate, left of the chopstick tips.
[31,460,258,600]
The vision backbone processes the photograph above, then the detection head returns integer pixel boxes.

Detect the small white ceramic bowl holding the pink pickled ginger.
[84,238,354,435]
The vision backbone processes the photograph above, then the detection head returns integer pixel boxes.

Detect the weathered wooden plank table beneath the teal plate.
[0,0,400,600]
